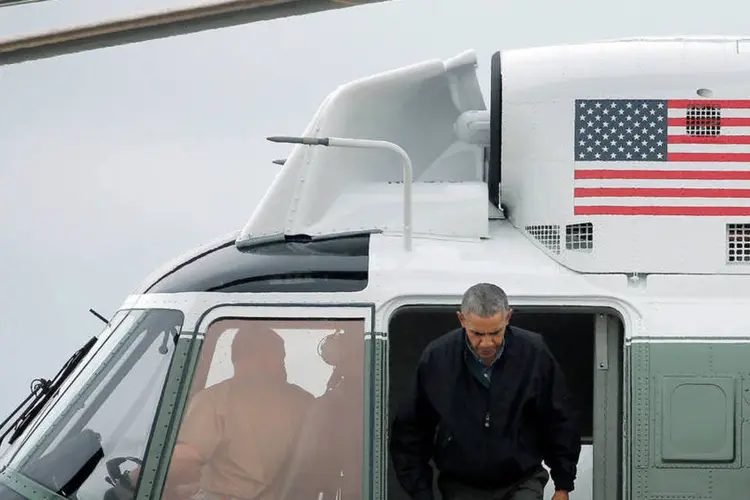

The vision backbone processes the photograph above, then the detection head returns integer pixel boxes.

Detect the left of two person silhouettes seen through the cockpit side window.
[165,326,314,500]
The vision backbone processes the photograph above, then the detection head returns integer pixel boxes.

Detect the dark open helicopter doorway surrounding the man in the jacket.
[387,304,623,500]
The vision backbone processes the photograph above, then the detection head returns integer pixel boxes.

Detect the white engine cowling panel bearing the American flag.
[502,37,750,274]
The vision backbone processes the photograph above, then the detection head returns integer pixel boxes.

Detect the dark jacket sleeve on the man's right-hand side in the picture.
[541,349,581,492]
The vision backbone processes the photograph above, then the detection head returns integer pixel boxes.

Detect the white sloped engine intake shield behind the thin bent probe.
[240,51,488,244]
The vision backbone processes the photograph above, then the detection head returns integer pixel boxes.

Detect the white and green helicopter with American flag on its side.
[0,2,750,500]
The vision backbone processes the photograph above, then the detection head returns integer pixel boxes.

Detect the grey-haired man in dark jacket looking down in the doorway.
[390,283,581,500]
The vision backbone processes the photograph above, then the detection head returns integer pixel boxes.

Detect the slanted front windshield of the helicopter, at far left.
[0,309,183,500]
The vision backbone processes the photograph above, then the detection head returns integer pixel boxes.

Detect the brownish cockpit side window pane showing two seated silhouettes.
[162,318,364,500]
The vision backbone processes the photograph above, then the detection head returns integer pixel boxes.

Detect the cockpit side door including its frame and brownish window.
[147,304,384,500]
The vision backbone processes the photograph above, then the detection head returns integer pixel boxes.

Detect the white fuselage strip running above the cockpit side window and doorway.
[129,225,750,341]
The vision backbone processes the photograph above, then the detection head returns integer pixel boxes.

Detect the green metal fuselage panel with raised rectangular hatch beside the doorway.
[630,340,750,500]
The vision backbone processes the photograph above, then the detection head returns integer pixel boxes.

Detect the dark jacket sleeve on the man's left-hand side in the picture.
[390,354,438,500]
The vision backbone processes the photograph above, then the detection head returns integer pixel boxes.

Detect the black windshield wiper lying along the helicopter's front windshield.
[0,337,97,444]
